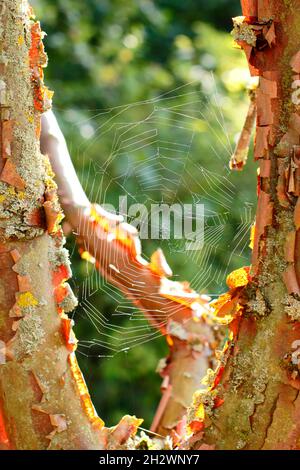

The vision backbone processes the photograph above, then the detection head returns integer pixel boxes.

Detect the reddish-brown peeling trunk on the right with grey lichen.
[185,0,300,449]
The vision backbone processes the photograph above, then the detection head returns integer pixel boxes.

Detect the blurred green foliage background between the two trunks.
[32,0,255,427]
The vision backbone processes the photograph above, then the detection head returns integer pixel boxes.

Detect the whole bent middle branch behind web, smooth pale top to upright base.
[42,106,218,435]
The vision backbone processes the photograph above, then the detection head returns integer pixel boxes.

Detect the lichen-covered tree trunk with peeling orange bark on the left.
[0,0,140,449]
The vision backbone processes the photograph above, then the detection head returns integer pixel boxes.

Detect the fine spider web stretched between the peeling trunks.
[64,78,253,357]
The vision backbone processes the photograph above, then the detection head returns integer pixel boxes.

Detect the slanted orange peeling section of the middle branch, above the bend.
[75,207,209,332]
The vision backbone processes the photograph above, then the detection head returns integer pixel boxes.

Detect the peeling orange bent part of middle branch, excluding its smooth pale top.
[76,208,219,435]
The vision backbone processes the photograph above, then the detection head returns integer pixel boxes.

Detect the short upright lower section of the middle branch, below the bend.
[151,312,218,435]
